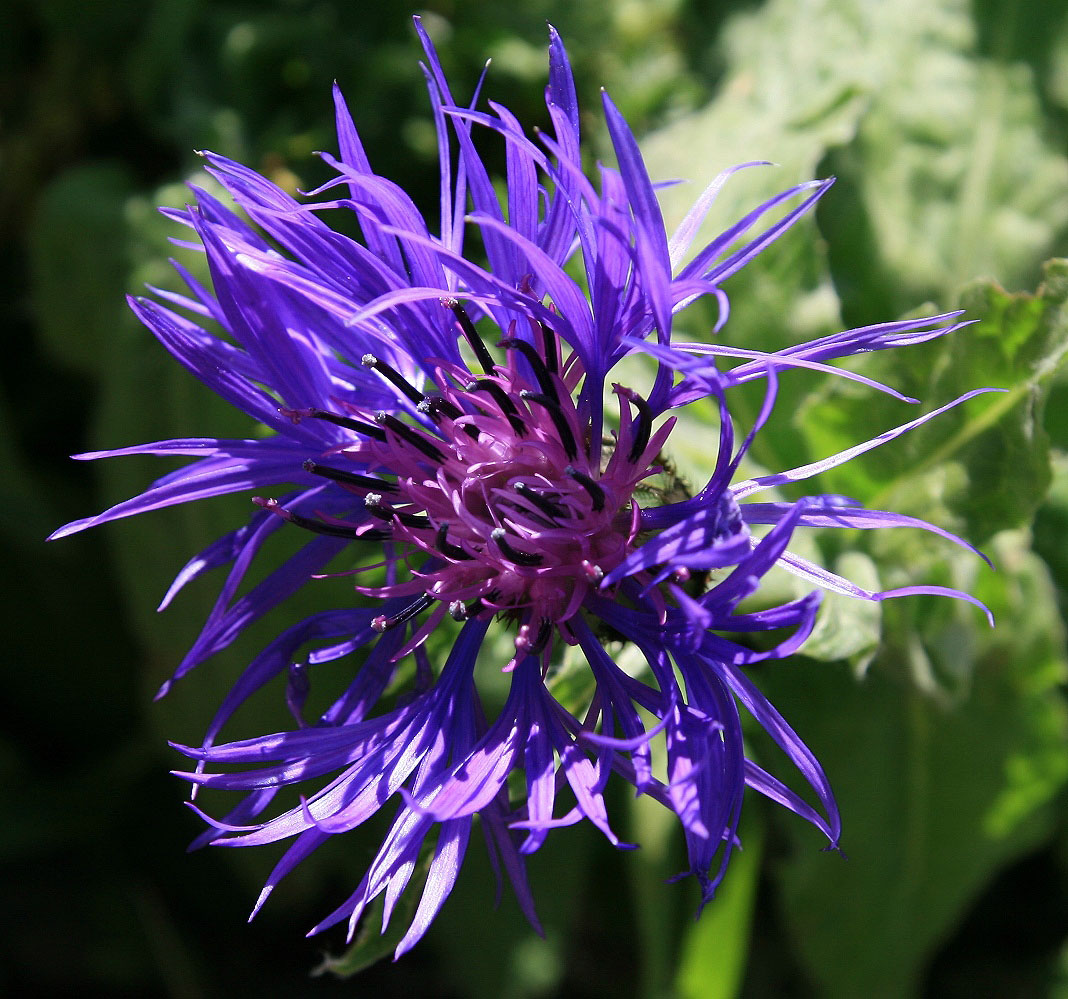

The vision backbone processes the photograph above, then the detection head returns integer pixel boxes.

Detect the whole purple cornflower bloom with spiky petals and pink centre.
[56,20,995,955]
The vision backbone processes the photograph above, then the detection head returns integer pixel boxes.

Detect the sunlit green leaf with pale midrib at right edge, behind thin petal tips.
[798,254,1068,544]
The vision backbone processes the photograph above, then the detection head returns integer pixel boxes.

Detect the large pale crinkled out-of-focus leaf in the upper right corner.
[643,0,1068,480]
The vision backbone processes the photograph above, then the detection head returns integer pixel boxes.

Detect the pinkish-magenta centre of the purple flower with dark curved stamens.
[266,306,671,649]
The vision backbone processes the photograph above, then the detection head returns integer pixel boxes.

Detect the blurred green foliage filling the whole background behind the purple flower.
[6,0,1068,999]
